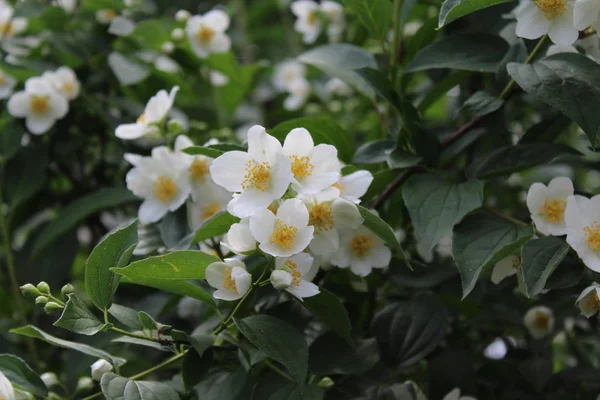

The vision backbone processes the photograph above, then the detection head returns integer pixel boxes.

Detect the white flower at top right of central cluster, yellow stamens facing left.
[283,128,340,194]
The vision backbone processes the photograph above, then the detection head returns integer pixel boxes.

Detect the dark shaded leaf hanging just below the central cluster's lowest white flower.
[302,288,354,346]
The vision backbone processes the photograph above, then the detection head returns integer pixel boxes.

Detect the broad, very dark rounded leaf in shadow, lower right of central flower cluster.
[371,295,449,367]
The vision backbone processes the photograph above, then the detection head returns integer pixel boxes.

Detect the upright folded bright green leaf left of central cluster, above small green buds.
[85,221,138,310]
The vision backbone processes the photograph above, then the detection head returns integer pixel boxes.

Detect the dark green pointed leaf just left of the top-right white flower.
[404,33,508,72]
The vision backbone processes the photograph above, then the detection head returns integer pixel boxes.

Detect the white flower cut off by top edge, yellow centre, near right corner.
[514,0,579,46]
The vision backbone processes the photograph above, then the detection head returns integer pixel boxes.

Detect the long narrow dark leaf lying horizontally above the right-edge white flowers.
[466,143,580,179]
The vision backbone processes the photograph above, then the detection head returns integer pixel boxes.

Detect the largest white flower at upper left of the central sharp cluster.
[210,125,293,218]
